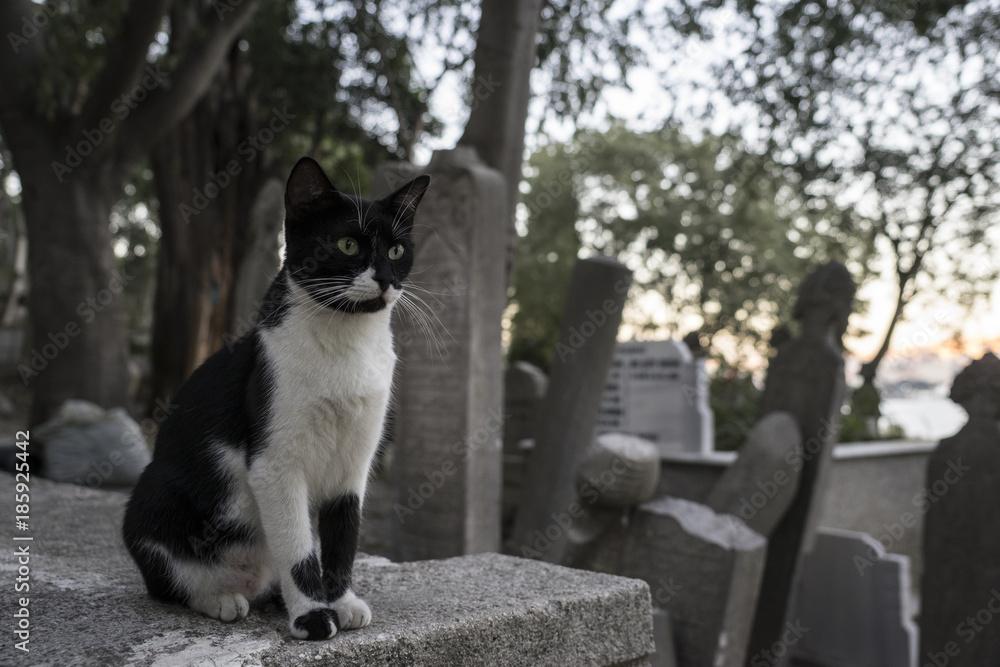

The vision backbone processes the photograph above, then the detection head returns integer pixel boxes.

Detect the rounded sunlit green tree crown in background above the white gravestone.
[512,124,869,362]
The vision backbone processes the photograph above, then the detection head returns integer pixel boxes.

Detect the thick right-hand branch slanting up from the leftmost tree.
[119,0,257,167]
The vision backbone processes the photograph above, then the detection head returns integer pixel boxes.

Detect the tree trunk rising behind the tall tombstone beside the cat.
[458,0,544,282]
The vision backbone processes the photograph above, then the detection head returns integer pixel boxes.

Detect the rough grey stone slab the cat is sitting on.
[0,473,654,667]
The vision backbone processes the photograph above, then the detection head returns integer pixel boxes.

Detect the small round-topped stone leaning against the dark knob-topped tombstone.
[707,412,802,537]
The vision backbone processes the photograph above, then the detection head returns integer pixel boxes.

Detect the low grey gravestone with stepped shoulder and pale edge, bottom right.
[789,528,916,667]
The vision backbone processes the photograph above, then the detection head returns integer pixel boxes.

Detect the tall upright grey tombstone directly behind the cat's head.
[375,147,507,560]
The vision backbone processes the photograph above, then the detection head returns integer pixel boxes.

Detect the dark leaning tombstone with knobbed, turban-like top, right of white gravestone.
[747,262,855,667]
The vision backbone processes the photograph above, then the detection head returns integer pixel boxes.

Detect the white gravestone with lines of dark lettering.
[597,340,715,454]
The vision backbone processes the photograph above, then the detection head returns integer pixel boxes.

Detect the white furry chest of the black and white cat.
[260,306,396,495]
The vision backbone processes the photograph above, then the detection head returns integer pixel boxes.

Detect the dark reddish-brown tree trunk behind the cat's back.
[152,48,271,405]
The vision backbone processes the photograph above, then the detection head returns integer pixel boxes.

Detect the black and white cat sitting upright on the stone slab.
[123,158,429,639]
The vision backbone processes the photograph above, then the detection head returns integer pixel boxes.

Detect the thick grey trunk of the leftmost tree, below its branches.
[18,150,131,425]
